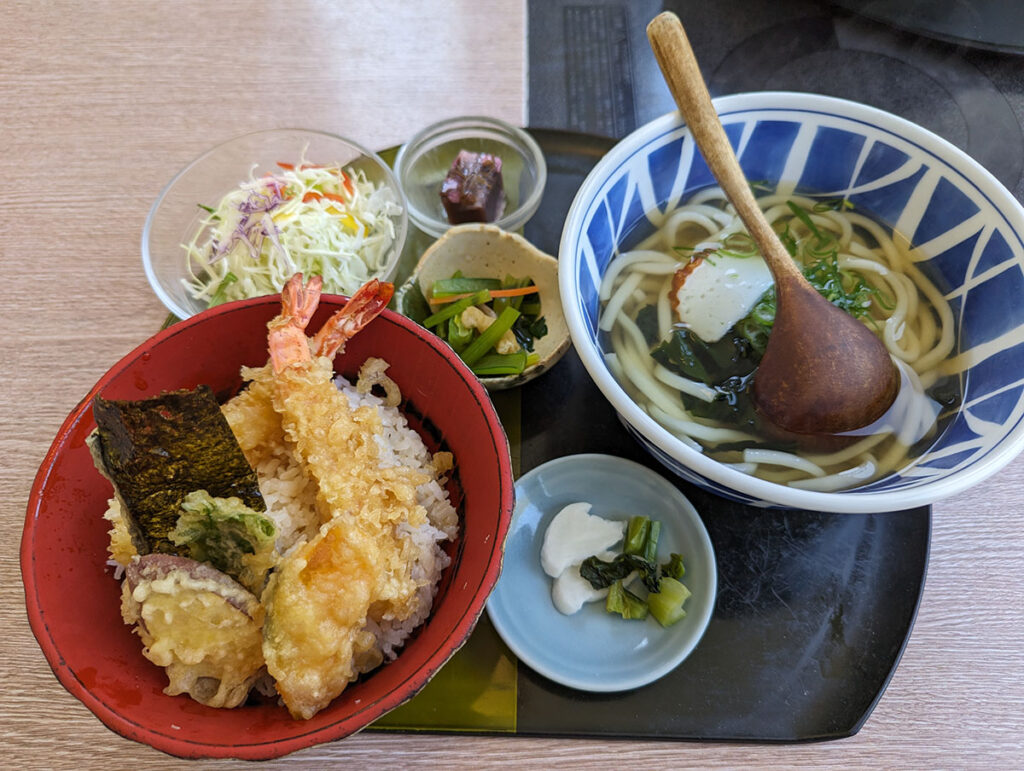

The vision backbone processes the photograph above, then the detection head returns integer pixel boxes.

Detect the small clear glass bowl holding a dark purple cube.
[394,116,548,238]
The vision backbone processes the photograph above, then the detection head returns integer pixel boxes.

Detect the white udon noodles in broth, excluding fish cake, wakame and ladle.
[599,188,959,490]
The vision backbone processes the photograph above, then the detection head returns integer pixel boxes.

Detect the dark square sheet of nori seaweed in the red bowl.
[91,386,266,556]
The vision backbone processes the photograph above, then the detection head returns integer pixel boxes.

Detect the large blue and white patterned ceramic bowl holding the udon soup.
[559,92,1024,512]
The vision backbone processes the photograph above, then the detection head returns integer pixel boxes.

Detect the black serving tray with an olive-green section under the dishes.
[377,129,931,741]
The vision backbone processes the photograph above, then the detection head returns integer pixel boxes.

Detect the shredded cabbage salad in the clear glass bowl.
[182,157,401,305]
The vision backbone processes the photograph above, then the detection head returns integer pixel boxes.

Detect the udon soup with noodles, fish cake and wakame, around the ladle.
[599,187,961,491]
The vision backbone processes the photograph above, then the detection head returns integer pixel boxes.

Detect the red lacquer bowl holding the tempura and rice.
[22,295,514,760]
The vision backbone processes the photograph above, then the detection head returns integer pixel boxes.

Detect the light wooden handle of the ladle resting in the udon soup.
[647,11,804,283]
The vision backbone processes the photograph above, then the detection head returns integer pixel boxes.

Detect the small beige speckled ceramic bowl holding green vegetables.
[395,224,569,391]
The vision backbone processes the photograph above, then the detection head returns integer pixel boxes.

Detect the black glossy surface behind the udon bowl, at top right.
[528,0,1024,201]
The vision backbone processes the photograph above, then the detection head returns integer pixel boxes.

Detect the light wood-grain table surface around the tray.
[0,0,1024,769]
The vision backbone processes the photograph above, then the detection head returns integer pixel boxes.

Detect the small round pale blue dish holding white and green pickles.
[487,455,717,692]
